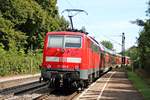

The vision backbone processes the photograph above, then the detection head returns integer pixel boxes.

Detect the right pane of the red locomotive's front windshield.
[65,36,81,48]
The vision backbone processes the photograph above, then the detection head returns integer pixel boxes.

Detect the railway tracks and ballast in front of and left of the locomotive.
[0,81,78,100]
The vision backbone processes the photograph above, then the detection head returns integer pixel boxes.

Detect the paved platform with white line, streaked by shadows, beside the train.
[77,71,144,100]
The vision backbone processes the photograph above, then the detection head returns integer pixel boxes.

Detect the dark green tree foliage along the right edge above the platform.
[138,1,150,71]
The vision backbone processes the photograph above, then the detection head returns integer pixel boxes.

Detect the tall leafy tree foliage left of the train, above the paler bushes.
[0,0,68,50]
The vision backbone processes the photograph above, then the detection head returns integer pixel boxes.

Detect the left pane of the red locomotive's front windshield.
[48,35,64,48]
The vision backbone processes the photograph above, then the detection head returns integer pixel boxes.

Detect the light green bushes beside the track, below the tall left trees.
[0,51,42,76]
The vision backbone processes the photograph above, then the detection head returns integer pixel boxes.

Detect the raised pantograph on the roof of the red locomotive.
[62,9,88,30]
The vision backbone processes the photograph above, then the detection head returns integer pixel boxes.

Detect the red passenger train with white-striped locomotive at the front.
[40,30,129,89]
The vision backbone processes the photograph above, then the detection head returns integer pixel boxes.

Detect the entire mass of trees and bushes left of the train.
[0,0,68,76]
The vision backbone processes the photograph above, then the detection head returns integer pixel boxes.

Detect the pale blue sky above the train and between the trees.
[57,0,148,52]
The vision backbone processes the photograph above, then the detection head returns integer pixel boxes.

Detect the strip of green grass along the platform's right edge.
[128,71,150,100]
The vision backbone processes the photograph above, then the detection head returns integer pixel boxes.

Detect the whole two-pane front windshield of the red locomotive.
[48,35,81,48]
